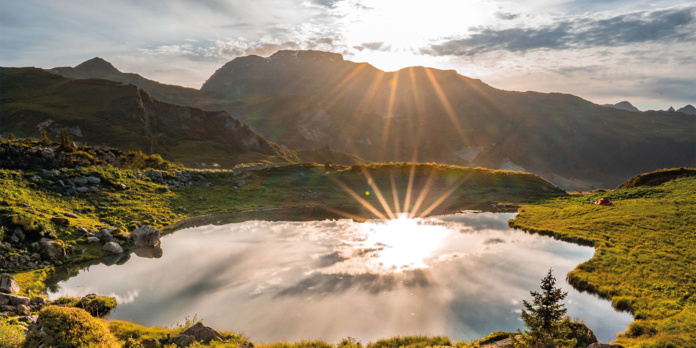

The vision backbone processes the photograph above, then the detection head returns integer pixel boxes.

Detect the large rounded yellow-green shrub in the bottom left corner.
[24,306,118,348]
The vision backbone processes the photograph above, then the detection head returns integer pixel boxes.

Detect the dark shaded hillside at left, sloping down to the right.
[0,67,294,166]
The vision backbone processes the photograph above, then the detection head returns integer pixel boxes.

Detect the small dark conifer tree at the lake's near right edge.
[515,269,575,348]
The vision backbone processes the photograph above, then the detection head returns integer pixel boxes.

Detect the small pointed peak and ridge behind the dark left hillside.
[47,57,202,106]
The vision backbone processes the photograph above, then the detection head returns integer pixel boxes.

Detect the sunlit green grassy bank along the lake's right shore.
[510,176,696,347]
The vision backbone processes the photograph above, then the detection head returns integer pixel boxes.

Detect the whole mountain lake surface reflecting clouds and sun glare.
[50,213,632,343]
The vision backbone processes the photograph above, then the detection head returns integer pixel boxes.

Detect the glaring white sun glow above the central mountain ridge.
[334,0,495,71]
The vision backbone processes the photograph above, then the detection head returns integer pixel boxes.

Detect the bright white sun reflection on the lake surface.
[321,213,451,275]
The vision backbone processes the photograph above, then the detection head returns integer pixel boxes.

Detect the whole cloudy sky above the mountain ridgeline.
[0,0,696,110]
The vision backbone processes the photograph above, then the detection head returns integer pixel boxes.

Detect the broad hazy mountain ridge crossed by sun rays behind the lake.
[42,51,696,189]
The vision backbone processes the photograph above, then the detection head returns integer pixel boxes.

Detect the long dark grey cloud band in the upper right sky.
[422,7,696,56]
